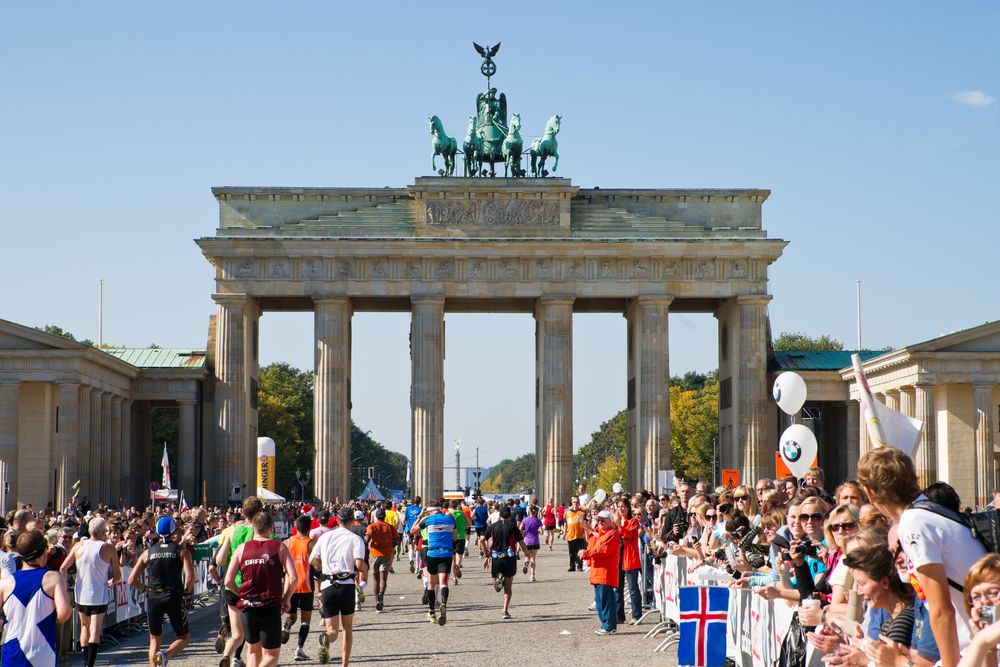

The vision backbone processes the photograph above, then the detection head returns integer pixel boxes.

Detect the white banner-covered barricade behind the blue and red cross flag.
[647,555,795,667]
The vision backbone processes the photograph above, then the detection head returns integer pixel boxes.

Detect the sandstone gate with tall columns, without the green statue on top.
[197,174,786,500]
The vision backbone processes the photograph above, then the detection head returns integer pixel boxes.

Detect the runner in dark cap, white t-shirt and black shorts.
[309,507,368,667]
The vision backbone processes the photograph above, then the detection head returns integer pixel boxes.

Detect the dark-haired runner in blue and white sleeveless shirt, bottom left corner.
[0,530,73,667]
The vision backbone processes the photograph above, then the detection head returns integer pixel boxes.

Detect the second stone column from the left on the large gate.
[313,298,351,501]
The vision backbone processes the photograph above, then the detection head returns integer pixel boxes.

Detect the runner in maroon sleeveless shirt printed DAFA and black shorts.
[219,511,298,667]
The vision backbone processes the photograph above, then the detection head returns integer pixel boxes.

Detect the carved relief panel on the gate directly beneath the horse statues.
[426,199,559,227]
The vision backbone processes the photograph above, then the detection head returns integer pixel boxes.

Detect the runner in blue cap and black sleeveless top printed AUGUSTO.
[128,516,194,667]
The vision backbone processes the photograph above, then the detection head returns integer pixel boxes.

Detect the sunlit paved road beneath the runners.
[66,542,676,667]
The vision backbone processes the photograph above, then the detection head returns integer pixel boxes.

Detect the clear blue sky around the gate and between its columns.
[0,1,1000,472]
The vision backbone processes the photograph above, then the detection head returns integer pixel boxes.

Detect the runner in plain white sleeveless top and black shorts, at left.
[59,517,122,667]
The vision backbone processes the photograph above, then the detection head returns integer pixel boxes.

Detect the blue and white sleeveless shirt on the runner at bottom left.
[0,568,56,667]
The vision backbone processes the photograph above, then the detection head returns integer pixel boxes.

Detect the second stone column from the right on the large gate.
[627,297,671,493]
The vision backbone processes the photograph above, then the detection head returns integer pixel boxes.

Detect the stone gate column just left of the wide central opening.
[410,297,444,504]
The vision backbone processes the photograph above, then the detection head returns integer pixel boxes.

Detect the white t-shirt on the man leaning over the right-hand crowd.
[899,494,986,650]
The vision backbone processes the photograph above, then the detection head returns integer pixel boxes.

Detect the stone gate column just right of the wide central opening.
[535,296,574,503]
